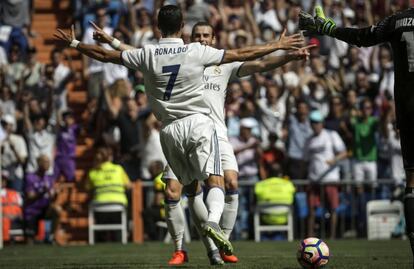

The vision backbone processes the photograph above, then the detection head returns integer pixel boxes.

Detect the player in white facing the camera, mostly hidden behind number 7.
[92,22,312,265]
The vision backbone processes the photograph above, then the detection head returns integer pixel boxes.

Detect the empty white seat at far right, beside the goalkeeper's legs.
[367,200,404,240]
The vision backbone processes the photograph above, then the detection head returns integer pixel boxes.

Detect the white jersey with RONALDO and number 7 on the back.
[121,38,224,124]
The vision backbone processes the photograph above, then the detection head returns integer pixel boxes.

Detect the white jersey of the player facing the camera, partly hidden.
[203,62,243,138]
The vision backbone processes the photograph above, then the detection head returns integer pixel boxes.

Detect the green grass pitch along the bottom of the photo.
[0,240,413,269]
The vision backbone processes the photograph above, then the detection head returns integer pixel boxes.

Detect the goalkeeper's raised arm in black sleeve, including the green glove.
[299,6,393,47]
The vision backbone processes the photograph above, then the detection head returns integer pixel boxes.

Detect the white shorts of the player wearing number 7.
[160,114,223,186]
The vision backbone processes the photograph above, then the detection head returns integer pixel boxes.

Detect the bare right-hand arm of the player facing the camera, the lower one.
[237,45,316,77]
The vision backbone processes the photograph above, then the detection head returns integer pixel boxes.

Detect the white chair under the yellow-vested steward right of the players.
[254,203,293,242]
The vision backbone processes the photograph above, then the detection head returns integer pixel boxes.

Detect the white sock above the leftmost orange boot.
[164,199,186,251]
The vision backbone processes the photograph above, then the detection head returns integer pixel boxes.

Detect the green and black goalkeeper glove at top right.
[299,6,336,36]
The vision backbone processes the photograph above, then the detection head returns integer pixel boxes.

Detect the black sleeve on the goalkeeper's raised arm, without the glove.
[334,15,395,47]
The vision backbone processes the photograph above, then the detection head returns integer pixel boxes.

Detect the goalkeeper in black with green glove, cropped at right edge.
[299,6,414,264]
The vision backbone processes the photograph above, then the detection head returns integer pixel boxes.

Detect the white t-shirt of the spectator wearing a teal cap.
[304,129,346,182]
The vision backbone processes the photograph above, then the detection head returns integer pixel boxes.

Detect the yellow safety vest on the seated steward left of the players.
[89,162,129,206]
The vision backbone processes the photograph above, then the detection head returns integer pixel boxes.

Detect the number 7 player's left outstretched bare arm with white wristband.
[54,25,122,64]
